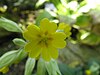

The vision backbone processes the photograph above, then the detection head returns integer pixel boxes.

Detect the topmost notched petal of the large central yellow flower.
[40,18,57,33]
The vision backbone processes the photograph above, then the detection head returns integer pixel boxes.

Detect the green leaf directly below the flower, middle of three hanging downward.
[37,58,46,75]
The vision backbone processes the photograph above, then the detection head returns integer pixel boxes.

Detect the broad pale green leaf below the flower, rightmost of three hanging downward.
[45,60,61,75]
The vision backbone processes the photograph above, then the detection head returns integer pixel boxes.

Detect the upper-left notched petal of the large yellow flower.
[23,25,40,40]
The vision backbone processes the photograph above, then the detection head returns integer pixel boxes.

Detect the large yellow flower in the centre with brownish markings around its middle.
[23,18,66,61]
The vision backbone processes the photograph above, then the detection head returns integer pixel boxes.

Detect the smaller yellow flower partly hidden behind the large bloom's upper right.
[58,23,71,37]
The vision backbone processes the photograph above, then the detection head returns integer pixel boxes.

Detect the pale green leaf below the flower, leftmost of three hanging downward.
[24,58,35,75]
